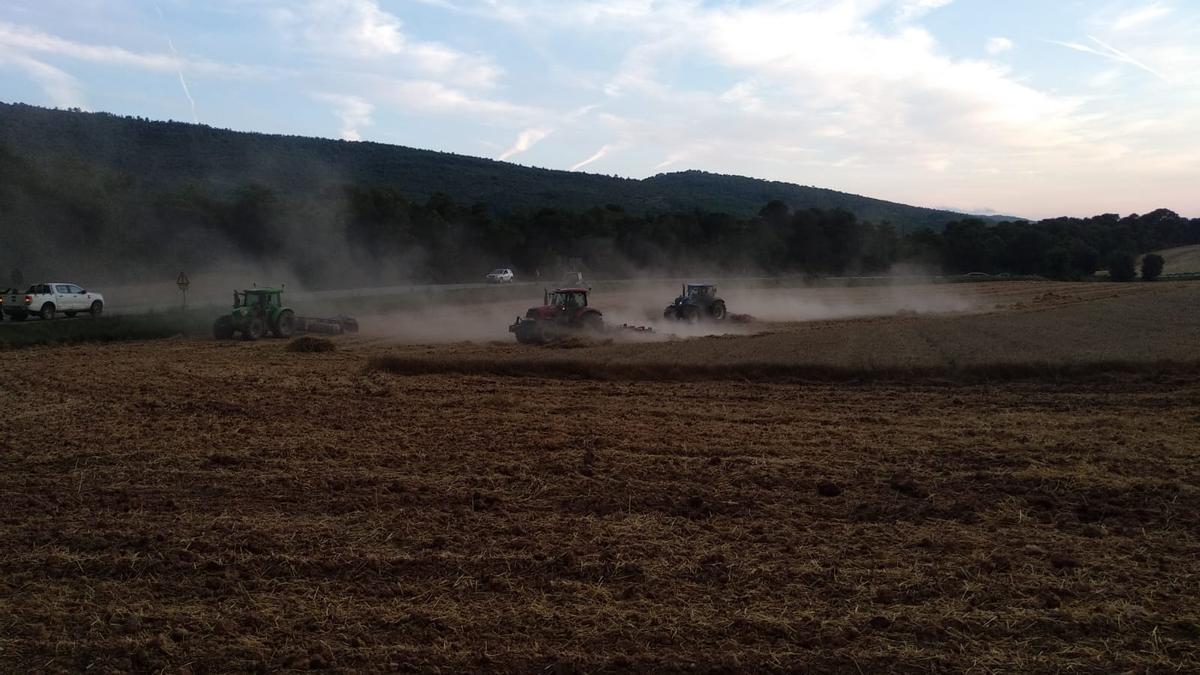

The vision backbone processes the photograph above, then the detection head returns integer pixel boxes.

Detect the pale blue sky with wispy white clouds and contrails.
[0,0,1200,217]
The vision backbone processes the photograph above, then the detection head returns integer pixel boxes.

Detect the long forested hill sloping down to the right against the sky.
[0,103,998,232]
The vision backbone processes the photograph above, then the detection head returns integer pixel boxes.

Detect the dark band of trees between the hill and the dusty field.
[0,102,1200,287]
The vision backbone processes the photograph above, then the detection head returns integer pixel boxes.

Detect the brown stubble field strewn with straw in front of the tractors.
[0,278,1200,673]
